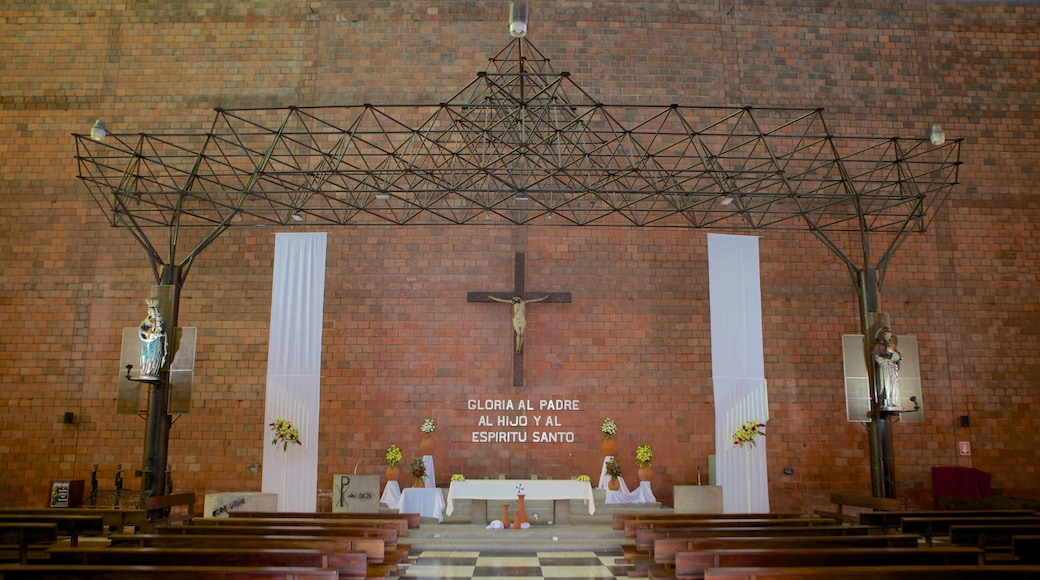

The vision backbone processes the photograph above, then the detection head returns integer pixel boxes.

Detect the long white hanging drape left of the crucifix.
[262,233,327,511]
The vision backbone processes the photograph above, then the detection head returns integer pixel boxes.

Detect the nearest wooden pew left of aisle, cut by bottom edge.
[0,564,339,580]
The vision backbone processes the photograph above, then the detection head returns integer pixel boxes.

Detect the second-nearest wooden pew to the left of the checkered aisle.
[48,548,368,580]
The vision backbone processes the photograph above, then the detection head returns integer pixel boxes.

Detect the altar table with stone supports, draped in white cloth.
[444,479,596,526]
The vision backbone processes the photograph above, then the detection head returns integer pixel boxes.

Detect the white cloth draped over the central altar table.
[444,479,596,516]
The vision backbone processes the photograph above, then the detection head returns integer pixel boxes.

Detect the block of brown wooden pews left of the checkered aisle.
[0,498,419,580]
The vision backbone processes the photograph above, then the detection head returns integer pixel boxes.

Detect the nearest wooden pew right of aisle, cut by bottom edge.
[704,565,1040,580]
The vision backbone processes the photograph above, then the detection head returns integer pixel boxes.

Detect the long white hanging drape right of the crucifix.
[708,234,770,512]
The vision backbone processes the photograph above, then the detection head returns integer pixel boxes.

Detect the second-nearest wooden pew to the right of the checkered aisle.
[675,548,982,579]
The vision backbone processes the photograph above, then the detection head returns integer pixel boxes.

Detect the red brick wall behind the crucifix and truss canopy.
[0,0,1040,510]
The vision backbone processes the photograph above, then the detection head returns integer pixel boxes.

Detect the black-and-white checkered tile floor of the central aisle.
[400,549,629,580]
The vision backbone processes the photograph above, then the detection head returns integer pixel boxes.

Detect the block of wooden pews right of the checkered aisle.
[614,511,1040,580]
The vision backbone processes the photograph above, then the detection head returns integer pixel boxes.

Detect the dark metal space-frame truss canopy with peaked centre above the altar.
[75,38,960,274]
